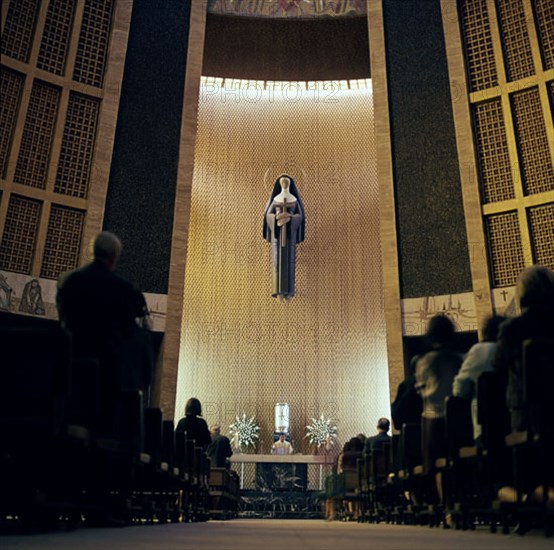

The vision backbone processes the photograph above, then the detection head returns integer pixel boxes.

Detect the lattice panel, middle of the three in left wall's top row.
[37,0,75,75]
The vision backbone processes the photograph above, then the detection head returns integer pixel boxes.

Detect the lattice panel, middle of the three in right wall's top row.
[496,0,535,80]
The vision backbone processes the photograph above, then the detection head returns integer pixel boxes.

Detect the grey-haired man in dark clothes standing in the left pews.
[56,231,153,429]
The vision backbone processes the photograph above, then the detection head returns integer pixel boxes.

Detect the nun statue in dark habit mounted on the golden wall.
[264,174,304,300]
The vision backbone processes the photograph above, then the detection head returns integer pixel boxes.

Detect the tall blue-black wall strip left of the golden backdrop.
[104,0,190,294]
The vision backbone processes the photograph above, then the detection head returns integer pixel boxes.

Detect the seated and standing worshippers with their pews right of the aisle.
[325,266,554,532]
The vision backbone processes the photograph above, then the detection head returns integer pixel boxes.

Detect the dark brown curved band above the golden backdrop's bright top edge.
[202,14,370,81]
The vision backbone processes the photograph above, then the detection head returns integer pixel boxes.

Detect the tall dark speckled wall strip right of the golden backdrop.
[384,0,471,298]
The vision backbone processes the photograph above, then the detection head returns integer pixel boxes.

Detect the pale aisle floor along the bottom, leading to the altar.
[0,519,554,550]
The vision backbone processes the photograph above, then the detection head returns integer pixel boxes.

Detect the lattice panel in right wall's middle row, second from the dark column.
[511,88,554,195]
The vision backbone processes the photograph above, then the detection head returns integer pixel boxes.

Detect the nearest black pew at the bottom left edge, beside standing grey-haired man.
[0,325,82,530]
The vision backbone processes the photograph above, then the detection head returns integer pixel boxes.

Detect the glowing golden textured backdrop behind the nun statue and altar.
[176,78,390,453]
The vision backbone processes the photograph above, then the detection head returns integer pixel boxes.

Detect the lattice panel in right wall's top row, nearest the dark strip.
[459,0,498,92]
